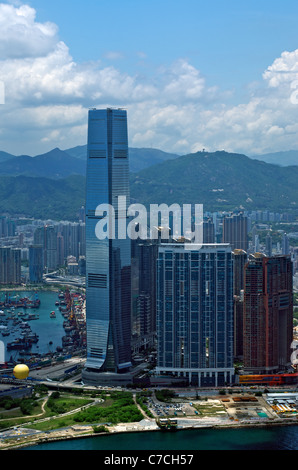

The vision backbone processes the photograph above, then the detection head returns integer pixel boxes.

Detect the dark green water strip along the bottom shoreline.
[25,425,298,451]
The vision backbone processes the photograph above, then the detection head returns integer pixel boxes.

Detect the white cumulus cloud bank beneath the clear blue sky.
[0,4,298,155]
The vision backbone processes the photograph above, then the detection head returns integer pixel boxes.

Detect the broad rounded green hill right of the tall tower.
[131,152,298,210]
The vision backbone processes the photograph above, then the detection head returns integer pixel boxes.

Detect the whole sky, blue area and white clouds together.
[0,0,298,155]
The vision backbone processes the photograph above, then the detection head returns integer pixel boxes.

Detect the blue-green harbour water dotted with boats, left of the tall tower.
[0,291,65,361]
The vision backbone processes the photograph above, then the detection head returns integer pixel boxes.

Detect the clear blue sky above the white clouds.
[28,0,298,93]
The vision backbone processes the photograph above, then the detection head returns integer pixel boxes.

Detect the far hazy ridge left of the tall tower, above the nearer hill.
[0,148,86,179]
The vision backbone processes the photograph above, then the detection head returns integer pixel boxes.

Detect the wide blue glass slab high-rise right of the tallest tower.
[156,243,234,386]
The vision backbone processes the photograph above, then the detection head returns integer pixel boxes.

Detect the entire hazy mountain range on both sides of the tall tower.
[0,146,298,220]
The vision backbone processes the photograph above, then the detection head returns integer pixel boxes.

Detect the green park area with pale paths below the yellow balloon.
[0,392,143,431]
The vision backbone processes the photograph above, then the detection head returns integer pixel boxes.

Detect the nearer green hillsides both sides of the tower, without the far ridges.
[0,152,298,220]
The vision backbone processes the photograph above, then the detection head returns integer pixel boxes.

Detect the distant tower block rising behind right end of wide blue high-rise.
[222,213,248,251]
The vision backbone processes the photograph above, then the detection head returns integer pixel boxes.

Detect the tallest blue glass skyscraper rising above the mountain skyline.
[83,109,131,381]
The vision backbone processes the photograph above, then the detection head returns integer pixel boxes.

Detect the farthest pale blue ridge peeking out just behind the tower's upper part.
[65,145,178,173]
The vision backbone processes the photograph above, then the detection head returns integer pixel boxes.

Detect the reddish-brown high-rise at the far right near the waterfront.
[243,253,293,374]
